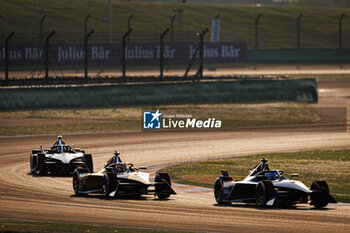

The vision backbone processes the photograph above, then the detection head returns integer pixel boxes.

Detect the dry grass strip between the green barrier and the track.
[0,102,322,136]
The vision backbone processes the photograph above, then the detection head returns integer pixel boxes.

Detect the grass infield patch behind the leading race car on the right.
[163,150,350,202]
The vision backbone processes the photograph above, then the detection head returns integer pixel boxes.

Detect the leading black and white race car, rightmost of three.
[214,158,337,208]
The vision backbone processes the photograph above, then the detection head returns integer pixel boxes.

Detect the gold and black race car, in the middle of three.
[73,152,176,199]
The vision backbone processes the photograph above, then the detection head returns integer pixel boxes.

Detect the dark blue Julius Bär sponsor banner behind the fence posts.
[0,42,247,66]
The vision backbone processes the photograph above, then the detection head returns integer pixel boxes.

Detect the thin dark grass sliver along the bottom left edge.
[0,220,186,233]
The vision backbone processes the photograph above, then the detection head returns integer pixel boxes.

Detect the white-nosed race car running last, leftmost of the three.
[30,136,93,175]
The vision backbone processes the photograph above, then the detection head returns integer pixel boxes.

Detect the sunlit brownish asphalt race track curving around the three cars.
[0,82,350,232]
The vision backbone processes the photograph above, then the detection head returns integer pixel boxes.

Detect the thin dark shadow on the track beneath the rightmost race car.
[213,203,335,211]
